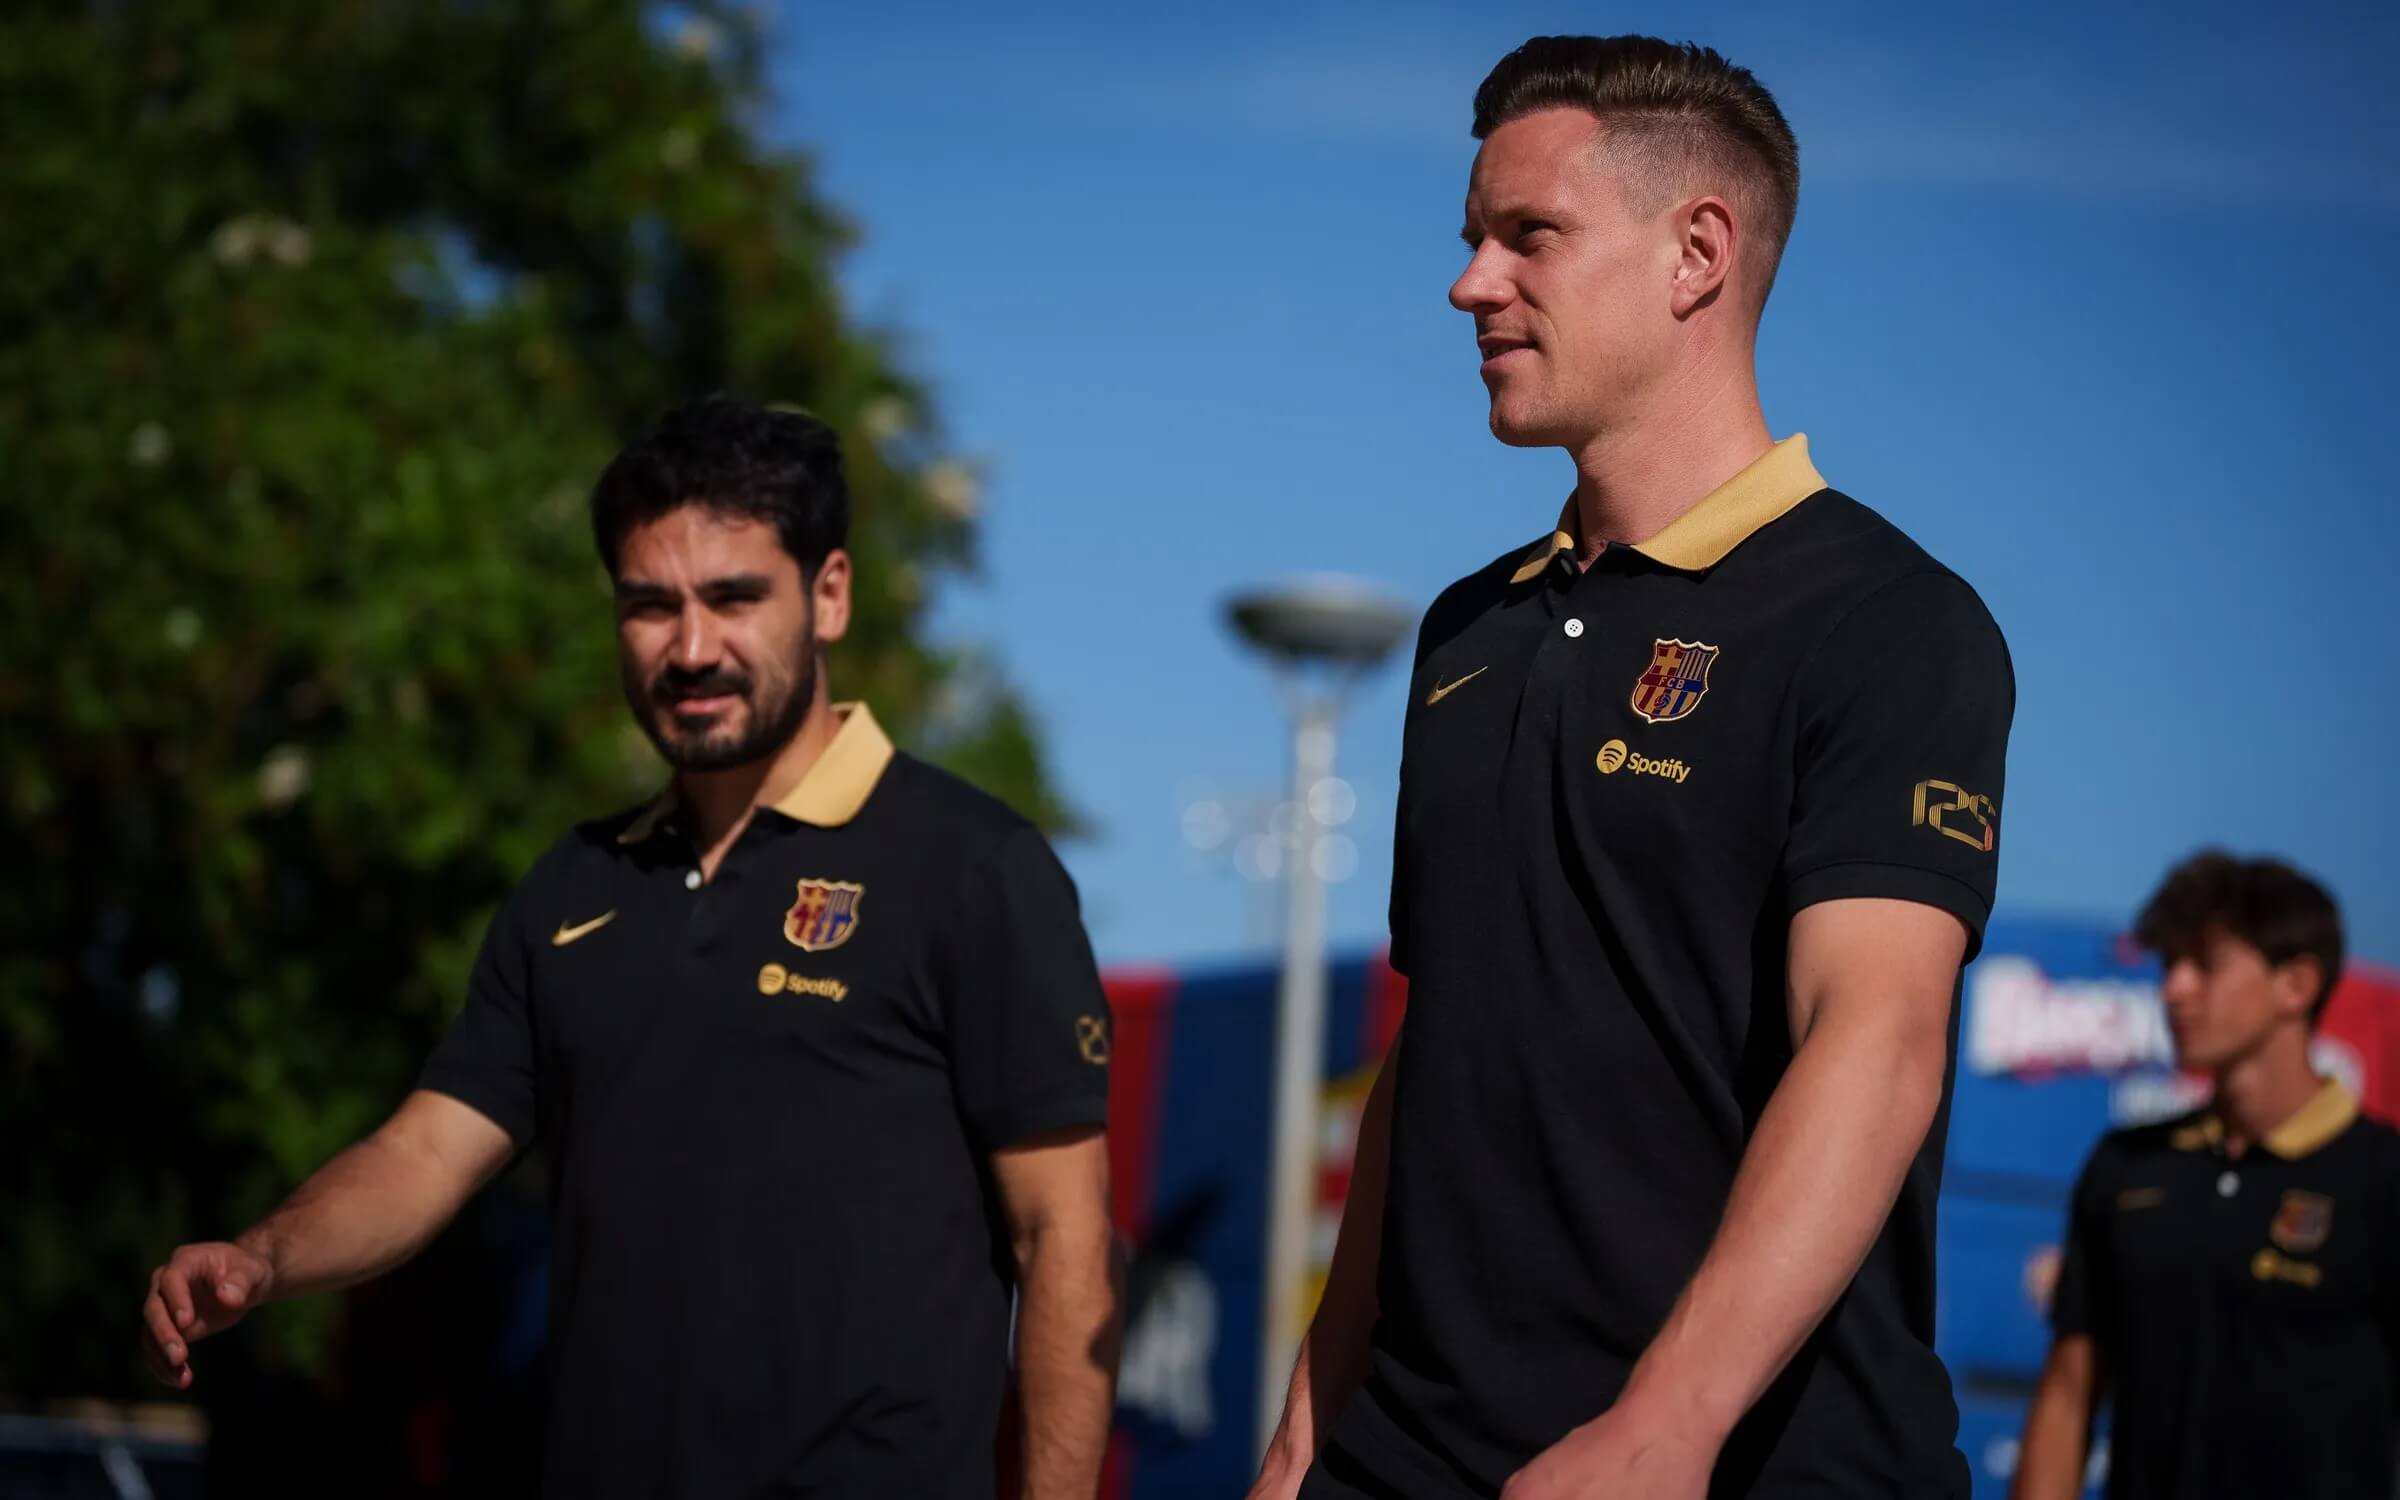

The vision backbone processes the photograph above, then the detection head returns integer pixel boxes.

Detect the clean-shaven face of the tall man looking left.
[1450,108,1680,449]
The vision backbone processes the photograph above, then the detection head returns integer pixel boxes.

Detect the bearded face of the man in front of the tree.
[617,506,850,770]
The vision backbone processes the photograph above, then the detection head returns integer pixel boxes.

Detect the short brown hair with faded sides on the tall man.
[1476,36,1800,307]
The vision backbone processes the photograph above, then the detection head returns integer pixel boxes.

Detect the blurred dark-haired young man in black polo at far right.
[2014,852,2400,1500]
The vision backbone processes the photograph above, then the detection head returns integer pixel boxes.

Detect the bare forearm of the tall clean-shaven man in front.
[1620,1020,1944,1440]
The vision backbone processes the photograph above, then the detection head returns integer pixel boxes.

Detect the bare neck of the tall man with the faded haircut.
[1574,341,1774,562]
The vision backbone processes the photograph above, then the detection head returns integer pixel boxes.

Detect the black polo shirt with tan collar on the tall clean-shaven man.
[1325,437,2014,1498]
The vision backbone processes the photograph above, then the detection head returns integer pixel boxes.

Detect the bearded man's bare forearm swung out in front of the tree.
[235,1099,506,1301]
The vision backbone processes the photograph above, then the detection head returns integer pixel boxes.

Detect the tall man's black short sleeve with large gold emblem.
[1783,571,2016,958]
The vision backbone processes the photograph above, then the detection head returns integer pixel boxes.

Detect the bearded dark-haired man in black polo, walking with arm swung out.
[142,398,1116,1500]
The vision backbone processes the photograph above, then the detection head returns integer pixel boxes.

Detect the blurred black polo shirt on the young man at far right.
[2050,1082,2400,1500]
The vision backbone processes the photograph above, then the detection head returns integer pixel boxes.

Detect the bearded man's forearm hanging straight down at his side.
[1018,1222,1123,1500]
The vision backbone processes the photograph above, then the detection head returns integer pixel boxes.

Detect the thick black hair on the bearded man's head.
[593,396,850,581]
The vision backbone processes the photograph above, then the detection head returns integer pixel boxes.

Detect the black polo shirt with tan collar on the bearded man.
[425,708,1109,1500]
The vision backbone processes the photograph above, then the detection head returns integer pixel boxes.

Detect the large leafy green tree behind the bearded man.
[0,0,1063,1397]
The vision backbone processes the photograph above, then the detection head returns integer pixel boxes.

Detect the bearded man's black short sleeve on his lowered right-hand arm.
[941,828,1114,1150]
